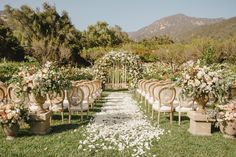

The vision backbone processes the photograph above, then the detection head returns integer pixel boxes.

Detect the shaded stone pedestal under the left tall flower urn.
[29,111,52,135]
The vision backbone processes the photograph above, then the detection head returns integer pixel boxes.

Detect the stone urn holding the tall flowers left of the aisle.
[29,93,47,114]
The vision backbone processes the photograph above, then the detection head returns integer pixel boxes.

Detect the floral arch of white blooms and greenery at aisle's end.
[94,51,143,88]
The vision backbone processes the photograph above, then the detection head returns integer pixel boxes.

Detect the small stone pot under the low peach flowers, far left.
[2,123,20,140]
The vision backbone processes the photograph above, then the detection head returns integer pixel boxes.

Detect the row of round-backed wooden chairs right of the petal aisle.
[136,79,196,125]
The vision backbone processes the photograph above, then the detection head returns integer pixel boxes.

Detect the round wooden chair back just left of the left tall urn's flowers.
[7,84,26,104]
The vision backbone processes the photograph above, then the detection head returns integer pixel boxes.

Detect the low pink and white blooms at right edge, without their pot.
[217,100,236,122]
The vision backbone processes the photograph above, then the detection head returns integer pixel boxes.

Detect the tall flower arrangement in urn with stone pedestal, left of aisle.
[9,62,71,135]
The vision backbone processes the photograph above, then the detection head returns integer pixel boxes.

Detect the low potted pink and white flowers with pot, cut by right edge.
[217,100,236,138]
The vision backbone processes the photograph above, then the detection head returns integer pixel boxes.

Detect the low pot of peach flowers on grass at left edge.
[0,104,29,140]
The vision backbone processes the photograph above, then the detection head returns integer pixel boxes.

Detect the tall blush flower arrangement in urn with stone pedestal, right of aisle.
[179,61,229,135]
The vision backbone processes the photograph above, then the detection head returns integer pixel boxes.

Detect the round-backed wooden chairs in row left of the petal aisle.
[0,80,102,123]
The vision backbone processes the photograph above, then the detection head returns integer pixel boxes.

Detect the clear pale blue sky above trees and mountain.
[0,0,236,32]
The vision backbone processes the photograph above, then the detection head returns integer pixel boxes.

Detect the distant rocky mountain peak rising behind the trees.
[128,14,225,41]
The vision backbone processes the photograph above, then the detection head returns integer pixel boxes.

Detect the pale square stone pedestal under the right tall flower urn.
[188,111,215,136]
